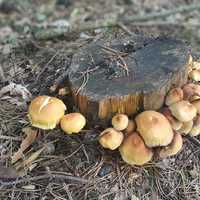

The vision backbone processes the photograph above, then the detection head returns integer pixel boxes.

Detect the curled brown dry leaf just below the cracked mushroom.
[11,127,37,164]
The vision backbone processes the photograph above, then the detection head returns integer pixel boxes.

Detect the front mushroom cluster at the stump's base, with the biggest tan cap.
[99,110,182,165]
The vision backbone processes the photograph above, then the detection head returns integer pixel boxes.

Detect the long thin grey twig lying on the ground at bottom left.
[0,174,89,187]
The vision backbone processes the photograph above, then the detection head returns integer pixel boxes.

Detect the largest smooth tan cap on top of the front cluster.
[135,111,173,147]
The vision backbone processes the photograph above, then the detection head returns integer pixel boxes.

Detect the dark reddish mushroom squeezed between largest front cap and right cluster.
[162,108,183,131]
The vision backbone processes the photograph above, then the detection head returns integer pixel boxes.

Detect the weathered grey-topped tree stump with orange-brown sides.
[69,37,189,120]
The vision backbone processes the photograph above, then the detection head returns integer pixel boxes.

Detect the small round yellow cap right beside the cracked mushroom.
[60,113,86,134]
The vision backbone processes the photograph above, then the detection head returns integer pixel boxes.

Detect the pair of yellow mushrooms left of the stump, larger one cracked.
[28,95,86,134]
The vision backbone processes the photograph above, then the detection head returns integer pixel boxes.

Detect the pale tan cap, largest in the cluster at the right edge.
[169,100,197,122]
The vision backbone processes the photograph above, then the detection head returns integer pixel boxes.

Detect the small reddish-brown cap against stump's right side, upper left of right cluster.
[165,88,183,106]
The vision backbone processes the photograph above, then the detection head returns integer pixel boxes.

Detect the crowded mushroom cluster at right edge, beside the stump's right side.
[161,83,200,136]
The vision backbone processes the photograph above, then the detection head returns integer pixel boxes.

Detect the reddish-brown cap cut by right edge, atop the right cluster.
[183,83,200,100]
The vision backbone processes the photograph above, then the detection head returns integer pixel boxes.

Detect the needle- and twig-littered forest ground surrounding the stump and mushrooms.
[0,0,200,200]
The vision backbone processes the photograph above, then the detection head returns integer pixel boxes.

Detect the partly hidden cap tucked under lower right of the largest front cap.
[159,133,183,158]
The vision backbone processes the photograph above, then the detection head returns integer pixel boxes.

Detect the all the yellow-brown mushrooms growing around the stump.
[28,57,200,165]
